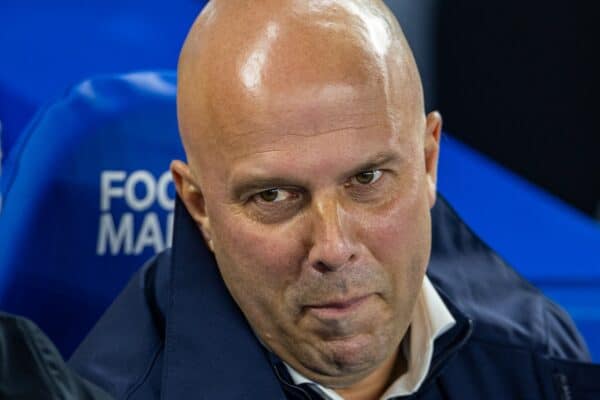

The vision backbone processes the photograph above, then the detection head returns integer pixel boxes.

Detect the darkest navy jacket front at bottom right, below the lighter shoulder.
[428,333,600,400]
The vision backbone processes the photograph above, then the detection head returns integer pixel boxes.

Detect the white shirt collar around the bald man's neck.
[284,276,456,400]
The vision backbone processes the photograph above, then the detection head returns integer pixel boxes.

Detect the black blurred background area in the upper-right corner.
[394,0,600,219]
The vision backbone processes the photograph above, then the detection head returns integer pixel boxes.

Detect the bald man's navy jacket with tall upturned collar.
[71,200,600,400]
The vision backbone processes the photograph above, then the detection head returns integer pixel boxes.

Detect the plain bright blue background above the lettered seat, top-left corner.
[0,0,206,162]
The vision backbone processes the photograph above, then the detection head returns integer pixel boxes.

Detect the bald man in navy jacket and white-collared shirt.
[72,0,589,399]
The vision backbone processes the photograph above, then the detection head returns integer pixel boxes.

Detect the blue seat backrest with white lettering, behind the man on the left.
[0,72,184,356]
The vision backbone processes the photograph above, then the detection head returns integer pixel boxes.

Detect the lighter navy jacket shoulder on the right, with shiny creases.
[428,198,589,361]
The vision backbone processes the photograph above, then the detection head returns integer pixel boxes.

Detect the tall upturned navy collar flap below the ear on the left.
[162,199,285,400]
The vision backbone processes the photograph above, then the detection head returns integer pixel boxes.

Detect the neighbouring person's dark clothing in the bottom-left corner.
[0,312,111,400]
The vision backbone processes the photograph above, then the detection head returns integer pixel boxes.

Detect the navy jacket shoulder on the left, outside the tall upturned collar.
[69,250,170,398]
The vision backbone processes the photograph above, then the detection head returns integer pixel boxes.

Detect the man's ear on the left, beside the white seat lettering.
[171,160,214,251]
